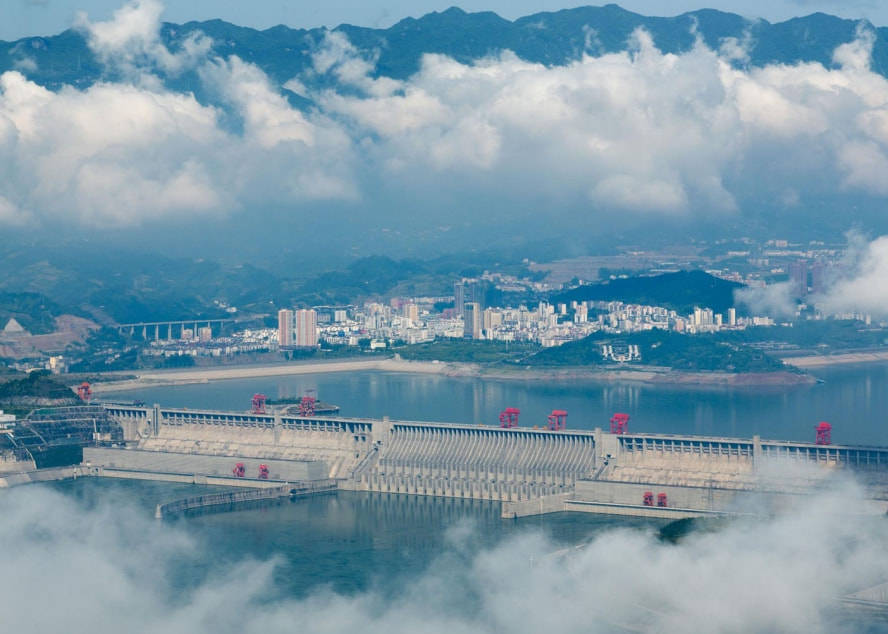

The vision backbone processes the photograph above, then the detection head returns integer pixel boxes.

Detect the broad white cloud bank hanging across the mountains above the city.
[0,0,888,230]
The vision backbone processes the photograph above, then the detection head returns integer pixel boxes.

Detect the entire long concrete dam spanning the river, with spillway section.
[6,404,888,519]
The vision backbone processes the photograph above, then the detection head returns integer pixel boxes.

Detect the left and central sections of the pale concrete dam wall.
[97,406,595,501]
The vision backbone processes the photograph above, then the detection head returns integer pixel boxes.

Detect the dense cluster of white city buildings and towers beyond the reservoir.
[262,280,774,358]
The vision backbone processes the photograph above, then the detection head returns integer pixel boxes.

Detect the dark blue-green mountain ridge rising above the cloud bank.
[0,4,888,89]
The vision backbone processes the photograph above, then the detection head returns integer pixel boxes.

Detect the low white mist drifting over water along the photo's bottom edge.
[0,472,888,634]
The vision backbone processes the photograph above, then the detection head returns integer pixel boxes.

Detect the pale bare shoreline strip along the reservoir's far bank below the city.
[86,358,816,394]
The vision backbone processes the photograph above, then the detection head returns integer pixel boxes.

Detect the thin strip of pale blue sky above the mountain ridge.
[0,0,888,40]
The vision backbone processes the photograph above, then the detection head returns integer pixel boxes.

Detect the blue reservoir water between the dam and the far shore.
[115,364,888,445]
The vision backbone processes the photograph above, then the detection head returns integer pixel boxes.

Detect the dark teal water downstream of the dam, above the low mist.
[50,478,663,599]
